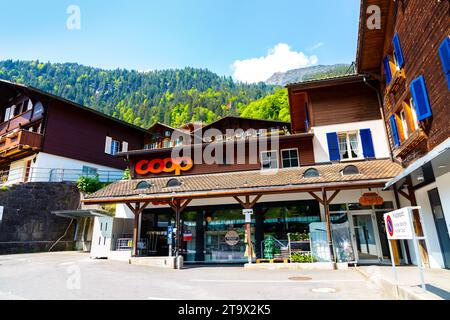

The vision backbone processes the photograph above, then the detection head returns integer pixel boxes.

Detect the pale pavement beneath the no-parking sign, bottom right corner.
[357,266,450,300]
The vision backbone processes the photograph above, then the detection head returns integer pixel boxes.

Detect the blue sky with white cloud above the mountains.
[0,0,360,82]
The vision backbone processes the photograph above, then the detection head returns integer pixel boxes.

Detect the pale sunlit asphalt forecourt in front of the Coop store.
[0,252,387,300]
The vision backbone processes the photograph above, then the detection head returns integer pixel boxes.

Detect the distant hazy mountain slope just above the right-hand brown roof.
[266,64,354,86]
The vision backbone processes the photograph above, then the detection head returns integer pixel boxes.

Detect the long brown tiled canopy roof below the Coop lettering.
[86,160,402,200]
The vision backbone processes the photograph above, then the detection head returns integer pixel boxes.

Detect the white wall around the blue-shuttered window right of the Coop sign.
[312,120,389,163]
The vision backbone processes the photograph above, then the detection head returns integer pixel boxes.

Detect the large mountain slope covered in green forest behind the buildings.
[0,60,278,128]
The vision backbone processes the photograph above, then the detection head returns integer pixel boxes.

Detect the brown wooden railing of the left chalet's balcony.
[0,129,43,158]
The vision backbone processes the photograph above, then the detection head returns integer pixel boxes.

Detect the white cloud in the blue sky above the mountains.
[231,43,318,83]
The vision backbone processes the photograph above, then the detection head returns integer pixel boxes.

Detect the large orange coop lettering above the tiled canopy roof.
[134,157,194,176]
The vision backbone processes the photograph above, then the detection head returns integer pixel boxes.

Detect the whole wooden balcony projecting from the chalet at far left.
[0,130,43,164]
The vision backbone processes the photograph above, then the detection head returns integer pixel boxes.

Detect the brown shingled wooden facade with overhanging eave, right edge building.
[357,0,450,166]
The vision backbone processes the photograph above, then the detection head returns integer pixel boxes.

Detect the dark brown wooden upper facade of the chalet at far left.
[0,81,149,170]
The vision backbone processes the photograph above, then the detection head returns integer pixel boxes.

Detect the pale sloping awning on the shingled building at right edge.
[384,138,450,190]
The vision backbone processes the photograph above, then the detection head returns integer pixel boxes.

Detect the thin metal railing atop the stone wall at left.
[0,167,123,185]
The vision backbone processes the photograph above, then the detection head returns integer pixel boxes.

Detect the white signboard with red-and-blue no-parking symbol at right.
[384,208,414,240]
